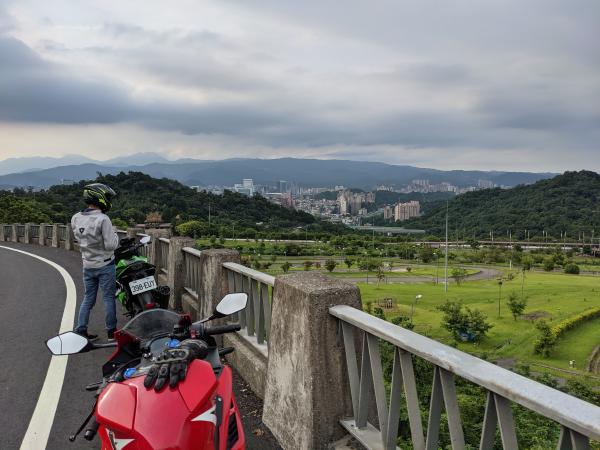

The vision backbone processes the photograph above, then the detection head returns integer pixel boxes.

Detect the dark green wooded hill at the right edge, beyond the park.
[402,171,600,240]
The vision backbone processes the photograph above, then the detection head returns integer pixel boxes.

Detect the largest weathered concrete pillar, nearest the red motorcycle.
[263,272,361,450]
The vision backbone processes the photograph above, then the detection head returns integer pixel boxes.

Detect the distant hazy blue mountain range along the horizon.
[0,153,555,189]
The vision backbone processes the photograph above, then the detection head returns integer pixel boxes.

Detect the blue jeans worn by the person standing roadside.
[75,261,117,333]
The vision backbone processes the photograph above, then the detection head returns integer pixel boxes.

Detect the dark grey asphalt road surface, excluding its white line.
[0,242,278,450]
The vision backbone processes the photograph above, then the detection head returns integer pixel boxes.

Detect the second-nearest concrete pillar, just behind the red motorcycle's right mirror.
[198,249,240,318]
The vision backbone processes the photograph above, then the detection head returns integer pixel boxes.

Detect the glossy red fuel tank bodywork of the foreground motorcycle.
[96,360,218,450]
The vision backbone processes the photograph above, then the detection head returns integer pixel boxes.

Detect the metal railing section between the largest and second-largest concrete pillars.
[223,263,275,352]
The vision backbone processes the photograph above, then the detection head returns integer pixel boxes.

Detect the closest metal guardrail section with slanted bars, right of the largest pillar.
[329,306,600,450]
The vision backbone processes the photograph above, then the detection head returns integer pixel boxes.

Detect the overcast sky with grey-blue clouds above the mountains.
[0,0,600,171]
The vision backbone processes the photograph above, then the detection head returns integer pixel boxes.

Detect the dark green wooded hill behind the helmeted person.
[0,172,342,236]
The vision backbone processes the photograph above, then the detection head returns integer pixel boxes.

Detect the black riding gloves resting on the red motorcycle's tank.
[144,339,208,392]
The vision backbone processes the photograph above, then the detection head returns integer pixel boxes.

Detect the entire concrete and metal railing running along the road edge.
[0,224,600,450]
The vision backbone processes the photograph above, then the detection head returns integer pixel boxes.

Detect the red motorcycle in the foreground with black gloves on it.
[46,294,247,450]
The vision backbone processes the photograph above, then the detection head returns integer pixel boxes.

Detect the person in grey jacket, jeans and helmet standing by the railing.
[71,183,119,341]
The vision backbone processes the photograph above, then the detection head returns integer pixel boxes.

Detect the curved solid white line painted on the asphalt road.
[0,245,77,450]
